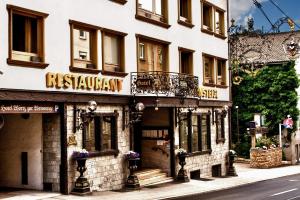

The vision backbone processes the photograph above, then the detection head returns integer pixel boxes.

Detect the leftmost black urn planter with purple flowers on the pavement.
[72,149,90,195]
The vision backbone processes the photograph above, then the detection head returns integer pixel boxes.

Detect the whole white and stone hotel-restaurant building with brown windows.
[0,0,231,194]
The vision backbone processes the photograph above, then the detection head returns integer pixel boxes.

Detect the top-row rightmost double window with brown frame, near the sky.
[202,1,225,38]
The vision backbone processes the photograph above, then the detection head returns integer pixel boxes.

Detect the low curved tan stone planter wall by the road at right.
[250,147,282,168]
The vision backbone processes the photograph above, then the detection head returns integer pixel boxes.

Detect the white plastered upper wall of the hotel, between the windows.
[0,0,229,100]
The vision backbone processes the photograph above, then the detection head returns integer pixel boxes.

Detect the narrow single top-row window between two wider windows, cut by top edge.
[178,0,194,28]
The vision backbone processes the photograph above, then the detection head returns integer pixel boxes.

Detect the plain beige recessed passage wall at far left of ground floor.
[0,114,43,190]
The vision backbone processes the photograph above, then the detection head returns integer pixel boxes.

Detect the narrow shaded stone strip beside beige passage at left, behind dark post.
[43,114,61,192]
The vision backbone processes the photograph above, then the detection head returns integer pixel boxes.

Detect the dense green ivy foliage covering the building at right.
[232,62,299,141]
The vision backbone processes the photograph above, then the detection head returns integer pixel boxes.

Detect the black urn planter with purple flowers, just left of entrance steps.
[124,151,140,189]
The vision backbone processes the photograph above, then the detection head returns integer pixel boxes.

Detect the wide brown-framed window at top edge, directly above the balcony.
[136,0,170,28]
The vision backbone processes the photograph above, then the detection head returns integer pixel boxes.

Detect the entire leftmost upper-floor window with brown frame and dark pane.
[7,5,48,68]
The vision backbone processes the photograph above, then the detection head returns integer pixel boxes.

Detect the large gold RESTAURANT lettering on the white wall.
[46,72,123,92]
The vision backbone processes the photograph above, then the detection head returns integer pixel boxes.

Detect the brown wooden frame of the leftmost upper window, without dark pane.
[6,4,49,69]
